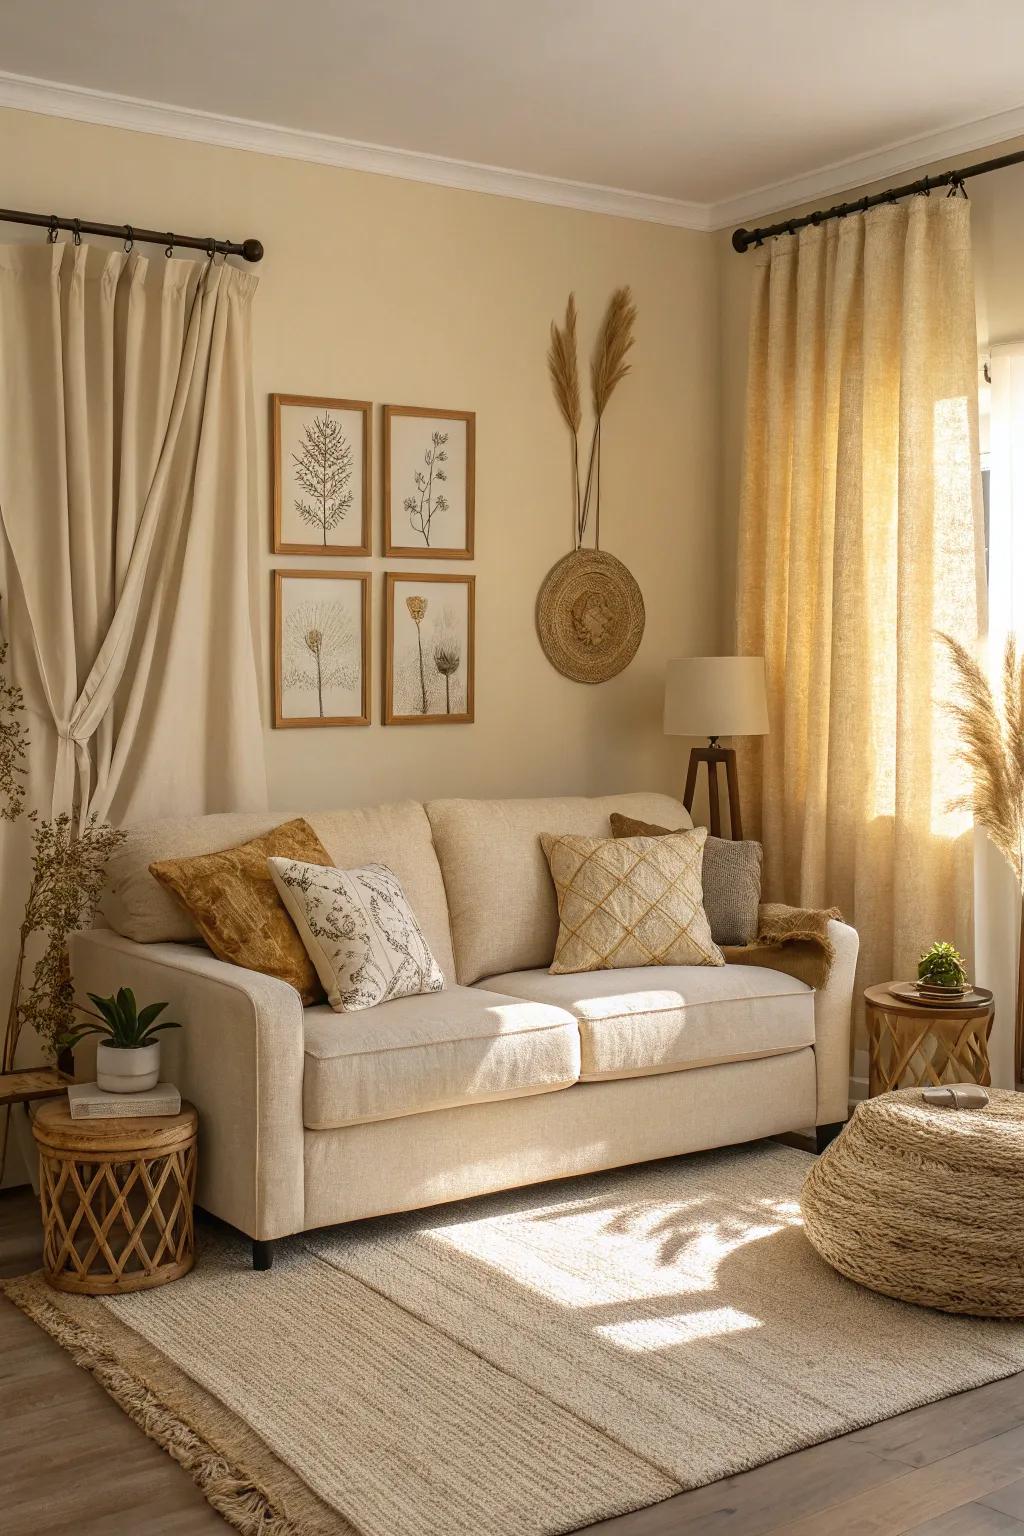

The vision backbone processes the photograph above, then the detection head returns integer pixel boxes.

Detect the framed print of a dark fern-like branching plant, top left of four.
[270,395,373,554]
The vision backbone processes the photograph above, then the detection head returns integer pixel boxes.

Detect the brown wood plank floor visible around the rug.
[0,1190,1024,1536]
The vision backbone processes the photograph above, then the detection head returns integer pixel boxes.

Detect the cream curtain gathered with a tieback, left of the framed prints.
[0,243,266,822]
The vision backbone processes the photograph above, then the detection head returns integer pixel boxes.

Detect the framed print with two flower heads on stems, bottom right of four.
[384,571,476,725]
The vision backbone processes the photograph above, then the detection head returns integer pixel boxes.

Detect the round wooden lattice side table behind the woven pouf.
[864,982,995,1098]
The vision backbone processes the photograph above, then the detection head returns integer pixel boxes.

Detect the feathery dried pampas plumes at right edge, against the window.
[940,634,1024,891]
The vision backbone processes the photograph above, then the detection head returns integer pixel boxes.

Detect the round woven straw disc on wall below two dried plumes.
[537,550,645,682]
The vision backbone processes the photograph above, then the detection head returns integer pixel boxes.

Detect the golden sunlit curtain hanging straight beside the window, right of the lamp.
[737,197,984,1032]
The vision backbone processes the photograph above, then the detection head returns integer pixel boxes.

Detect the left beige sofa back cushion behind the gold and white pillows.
[100,800,454,980]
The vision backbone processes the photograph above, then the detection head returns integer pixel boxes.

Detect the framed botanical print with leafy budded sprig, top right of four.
[384,406,476,561]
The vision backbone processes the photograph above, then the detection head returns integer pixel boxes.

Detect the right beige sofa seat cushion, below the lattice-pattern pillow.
[487,965,814,1081]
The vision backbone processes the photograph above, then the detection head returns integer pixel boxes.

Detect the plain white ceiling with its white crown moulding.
[0,0,1024,227]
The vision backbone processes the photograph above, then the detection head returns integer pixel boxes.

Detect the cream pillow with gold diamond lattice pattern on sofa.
[540,826,725,975]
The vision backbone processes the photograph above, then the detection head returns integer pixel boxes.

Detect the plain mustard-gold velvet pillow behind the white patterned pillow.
[149,817,333,1005]
